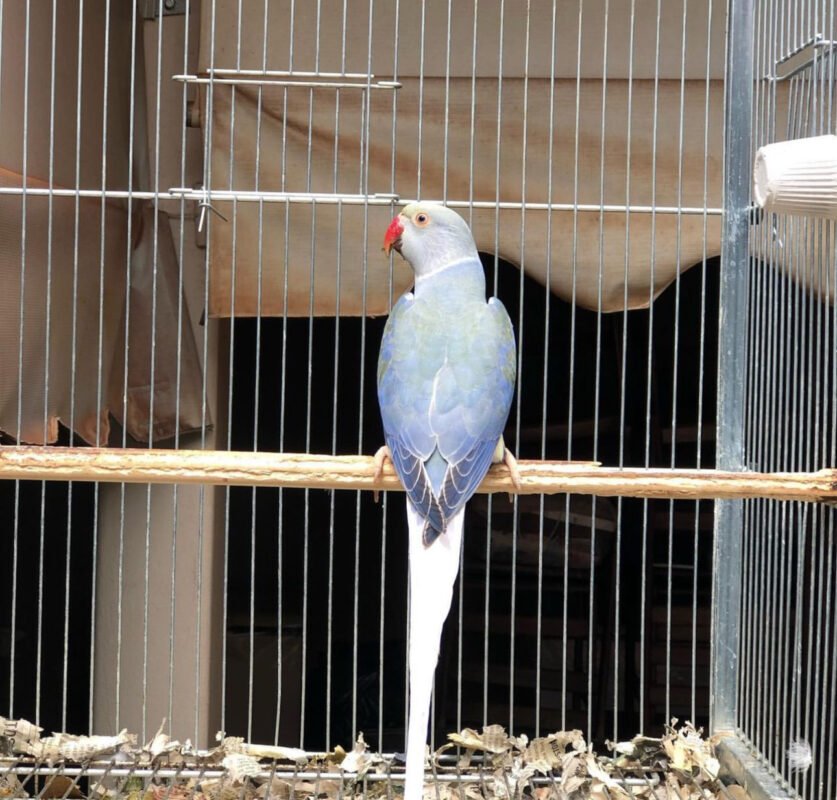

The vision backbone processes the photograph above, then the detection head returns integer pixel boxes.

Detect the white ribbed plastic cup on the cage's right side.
[753,135,837,219]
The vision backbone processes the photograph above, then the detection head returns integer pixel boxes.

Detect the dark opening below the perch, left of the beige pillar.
[0,427,96,735]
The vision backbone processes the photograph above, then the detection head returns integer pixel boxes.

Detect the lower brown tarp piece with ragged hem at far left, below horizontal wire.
[0,173,126,444]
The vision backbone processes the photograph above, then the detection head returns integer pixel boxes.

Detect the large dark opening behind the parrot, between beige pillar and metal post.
[226,258,718,751]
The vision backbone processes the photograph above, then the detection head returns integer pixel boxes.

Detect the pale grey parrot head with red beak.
[384,203,479,278]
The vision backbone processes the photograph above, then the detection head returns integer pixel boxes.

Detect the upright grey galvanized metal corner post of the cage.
[710,0,754,732]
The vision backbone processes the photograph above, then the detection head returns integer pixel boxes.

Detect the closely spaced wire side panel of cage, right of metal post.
[738,2,837,797]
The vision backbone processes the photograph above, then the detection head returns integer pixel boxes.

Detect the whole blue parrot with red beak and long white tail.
[375,203,520,800]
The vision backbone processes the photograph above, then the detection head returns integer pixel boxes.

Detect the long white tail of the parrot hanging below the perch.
[404,500,465,800]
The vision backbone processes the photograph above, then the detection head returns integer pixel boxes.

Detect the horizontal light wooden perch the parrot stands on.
[0,446,837,502]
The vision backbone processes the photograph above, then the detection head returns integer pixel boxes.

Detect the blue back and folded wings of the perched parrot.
[378,262,516,545]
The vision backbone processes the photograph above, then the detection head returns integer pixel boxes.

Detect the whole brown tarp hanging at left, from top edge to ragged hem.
[0,0,208,444]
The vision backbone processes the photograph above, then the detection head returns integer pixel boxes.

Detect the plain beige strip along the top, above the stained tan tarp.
[194,0,726,80]
